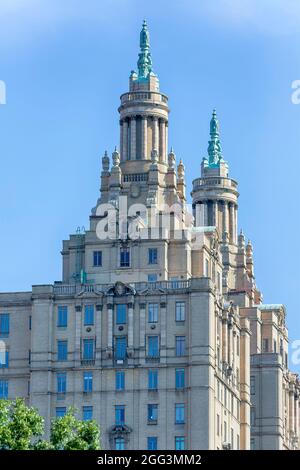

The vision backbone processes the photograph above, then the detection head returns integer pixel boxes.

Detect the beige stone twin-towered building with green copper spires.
[0,22,300,450]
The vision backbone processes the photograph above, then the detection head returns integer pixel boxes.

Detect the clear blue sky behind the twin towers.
[0,0,300,370]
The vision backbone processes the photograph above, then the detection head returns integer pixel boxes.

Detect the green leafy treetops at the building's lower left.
[0,398,100,450]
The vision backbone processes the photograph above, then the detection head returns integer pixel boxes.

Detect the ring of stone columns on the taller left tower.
[120,115,168,162]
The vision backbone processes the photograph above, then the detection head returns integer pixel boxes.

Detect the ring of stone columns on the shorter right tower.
[195,199,238,243]
